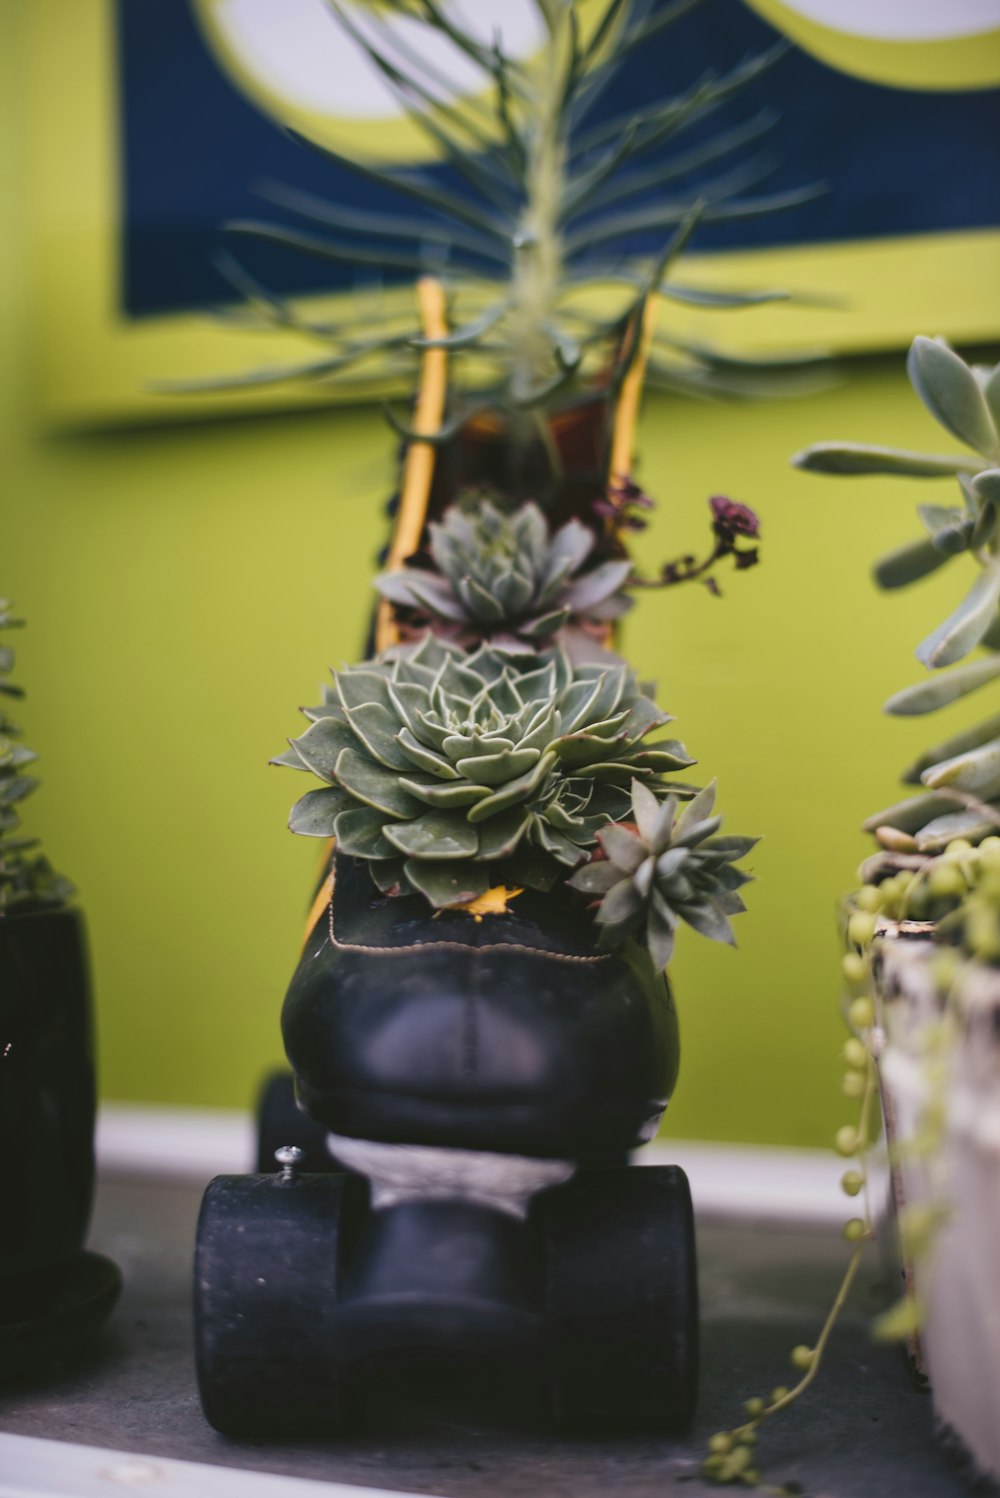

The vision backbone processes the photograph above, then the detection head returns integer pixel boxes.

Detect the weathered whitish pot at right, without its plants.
[873,920,1000,1480]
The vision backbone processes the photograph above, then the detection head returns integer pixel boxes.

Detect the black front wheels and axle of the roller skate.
[195,1167,698,1440]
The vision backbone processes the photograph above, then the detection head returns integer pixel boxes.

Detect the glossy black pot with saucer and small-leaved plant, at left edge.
[0,601,120,1377]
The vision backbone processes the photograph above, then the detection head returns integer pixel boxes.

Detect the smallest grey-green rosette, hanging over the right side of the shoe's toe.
[569,780,757,972]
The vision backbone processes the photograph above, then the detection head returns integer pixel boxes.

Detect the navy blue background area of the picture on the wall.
[117,0,1000,318]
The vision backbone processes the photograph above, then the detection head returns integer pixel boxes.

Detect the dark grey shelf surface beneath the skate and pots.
[0,1180,970,1498]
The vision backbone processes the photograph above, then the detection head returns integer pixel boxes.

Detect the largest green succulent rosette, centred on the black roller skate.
[277,635,693,908]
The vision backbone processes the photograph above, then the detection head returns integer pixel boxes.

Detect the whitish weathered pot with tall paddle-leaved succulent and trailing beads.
[793,339,1000,1480]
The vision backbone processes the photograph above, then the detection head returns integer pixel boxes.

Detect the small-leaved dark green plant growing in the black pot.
[0,599,73,915]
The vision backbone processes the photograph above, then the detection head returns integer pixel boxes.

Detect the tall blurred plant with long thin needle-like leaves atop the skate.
[162,0,820,428]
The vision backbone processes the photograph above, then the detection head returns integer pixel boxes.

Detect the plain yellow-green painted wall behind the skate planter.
[0,6,994,1144]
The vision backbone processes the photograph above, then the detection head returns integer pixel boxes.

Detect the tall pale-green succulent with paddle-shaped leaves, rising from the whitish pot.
[792,339,1000,854]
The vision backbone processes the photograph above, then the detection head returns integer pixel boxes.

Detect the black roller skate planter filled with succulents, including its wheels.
[187,0,808,1434]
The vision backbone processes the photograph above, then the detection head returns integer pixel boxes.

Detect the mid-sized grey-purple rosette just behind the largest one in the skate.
[376,496,632,649]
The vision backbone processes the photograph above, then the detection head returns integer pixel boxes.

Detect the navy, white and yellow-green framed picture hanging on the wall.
[21,0,1000,422]
